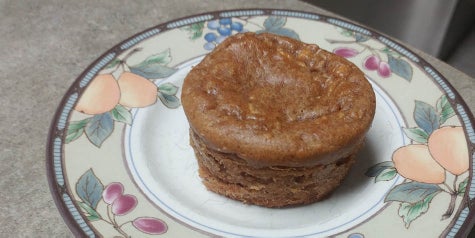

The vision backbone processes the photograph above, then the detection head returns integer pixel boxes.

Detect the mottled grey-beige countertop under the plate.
[0,0,475,237]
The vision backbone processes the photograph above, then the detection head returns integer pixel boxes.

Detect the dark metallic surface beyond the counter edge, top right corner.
[306,0,475,59]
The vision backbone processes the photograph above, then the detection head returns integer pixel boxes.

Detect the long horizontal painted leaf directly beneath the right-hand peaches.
[384,182,442,204]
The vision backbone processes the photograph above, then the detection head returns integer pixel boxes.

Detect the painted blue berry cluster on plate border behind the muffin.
[203,18,245,50]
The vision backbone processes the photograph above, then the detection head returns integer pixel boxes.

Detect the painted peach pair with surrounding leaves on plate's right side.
[366,95,469,231]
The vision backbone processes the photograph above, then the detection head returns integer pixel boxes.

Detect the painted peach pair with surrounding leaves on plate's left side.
[66,48,180,147]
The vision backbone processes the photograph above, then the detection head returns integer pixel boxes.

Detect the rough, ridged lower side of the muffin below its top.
[190,130,356,207]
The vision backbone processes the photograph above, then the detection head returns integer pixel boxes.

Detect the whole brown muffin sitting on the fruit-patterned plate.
[181,33,376,207]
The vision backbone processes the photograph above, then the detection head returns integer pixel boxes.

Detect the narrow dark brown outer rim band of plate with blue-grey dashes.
[45,8,475,237]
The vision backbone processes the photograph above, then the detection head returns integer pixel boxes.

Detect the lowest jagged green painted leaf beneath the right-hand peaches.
[398,193,437,228]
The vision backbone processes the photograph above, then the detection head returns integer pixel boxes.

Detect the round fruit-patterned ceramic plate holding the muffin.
[47,9,475,238]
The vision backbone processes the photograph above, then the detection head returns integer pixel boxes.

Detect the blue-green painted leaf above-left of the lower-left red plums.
[76,169,104,209]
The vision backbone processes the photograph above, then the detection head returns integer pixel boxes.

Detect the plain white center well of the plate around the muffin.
[124,58,407,237]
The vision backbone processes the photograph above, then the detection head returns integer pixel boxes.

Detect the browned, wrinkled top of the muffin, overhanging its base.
[181,33,375,166]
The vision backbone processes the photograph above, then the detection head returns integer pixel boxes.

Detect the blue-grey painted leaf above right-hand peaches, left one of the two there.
[414,100,440,135]
